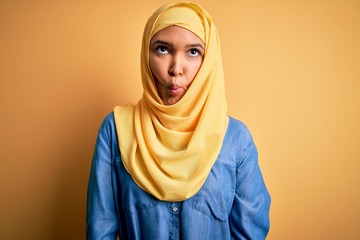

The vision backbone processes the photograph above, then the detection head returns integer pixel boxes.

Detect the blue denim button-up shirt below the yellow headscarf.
[86,113,270,240]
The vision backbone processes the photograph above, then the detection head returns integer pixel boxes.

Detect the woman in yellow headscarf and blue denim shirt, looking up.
[87,3,270,240]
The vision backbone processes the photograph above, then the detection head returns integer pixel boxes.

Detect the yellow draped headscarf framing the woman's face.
[114,2,228,201]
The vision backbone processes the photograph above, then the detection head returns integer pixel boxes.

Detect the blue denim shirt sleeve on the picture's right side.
[229,133,270,240]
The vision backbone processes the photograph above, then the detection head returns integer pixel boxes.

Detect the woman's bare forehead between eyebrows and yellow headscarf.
[151,26,204,46]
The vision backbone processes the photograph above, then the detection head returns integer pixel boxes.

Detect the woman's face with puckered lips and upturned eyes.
[149,26,205,105]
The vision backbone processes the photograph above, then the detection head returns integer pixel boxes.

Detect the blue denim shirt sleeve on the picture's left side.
[86,124,118,240]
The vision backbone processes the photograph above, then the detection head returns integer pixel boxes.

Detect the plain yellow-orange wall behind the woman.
[0,0,360,240]
